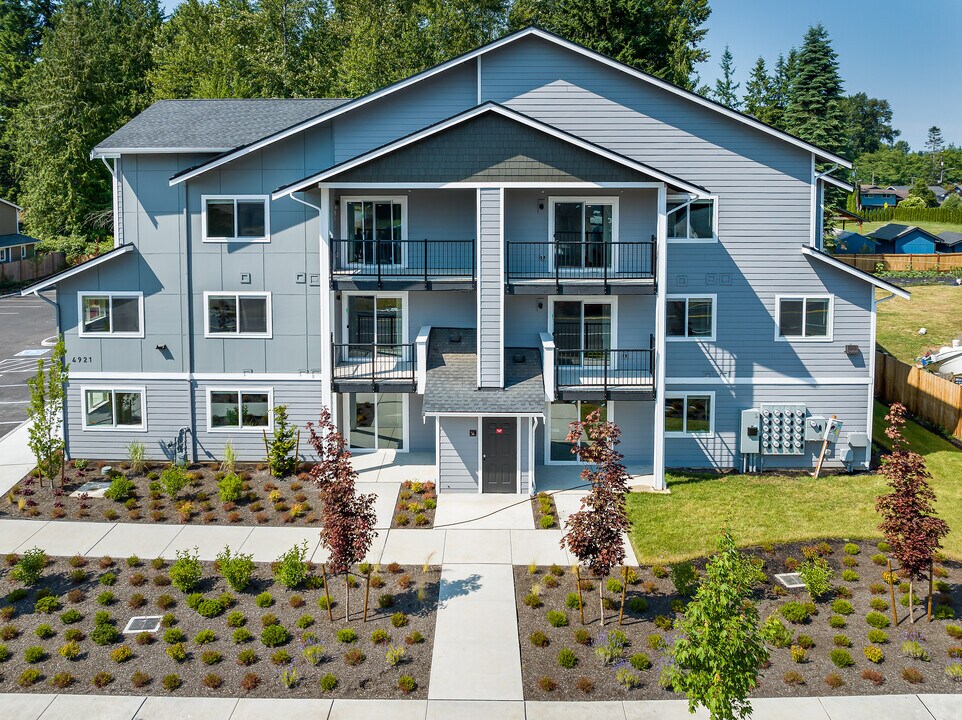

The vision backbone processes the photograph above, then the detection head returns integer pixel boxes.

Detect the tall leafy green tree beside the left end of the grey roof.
[11,0,161,246]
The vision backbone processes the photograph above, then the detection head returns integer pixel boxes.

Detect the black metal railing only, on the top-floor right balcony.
[505,233,656,284]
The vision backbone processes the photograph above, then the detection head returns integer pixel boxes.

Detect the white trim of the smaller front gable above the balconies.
[271,102,708,200]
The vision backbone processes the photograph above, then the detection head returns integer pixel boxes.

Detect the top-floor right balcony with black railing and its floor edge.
[505,232,656,295]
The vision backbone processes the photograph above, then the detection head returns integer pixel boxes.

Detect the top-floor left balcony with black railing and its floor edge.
[330,238,475,290]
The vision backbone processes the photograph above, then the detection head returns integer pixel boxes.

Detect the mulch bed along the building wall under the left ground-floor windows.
[0,462,334,526]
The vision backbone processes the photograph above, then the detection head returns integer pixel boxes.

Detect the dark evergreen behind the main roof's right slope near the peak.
[510,0,711,90]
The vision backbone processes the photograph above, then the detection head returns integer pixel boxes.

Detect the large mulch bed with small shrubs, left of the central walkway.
[0,557,440,698]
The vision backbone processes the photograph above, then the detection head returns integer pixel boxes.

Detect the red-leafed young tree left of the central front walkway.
[307,408,377,620]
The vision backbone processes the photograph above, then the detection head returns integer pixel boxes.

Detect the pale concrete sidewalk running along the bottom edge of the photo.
[0,694,962,720]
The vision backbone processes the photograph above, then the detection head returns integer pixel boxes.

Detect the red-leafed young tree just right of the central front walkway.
[561,410,628,625]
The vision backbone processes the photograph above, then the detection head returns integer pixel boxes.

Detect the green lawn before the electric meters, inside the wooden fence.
[628,403,962,563]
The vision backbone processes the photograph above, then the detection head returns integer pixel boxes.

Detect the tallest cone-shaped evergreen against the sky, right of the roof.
[785,24,844,153]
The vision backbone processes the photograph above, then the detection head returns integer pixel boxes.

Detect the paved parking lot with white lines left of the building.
[0,297,56,437]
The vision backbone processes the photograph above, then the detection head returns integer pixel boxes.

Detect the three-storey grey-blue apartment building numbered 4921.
[24,29,908,493]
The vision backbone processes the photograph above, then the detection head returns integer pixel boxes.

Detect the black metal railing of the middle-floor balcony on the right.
[554,335,655,391]
